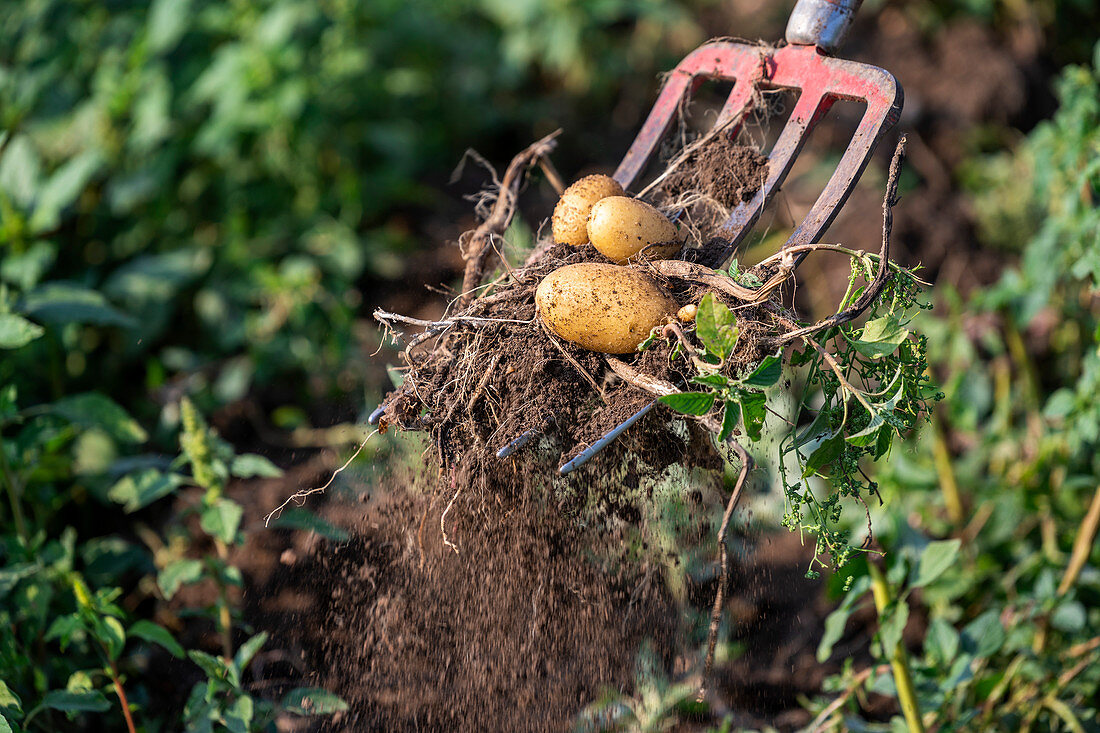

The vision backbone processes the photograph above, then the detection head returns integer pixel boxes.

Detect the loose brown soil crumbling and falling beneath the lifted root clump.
[266,488,679,731]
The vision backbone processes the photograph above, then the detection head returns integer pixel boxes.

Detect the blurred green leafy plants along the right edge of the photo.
[816,41,1100,731]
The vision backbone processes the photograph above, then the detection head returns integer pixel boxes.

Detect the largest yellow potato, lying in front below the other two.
[535,262,680,353]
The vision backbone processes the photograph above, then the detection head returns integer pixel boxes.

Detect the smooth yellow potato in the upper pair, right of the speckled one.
[589,196,681,264]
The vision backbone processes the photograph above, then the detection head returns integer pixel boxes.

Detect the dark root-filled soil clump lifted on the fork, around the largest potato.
[382,239,762,518]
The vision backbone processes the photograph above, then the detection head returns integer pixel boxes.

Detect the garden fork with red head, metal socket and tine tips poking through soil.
[371,0,903,474]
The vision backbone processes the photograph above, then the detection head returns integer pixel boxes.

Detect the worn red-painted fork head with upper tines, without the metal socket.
[615,41,903,267]
